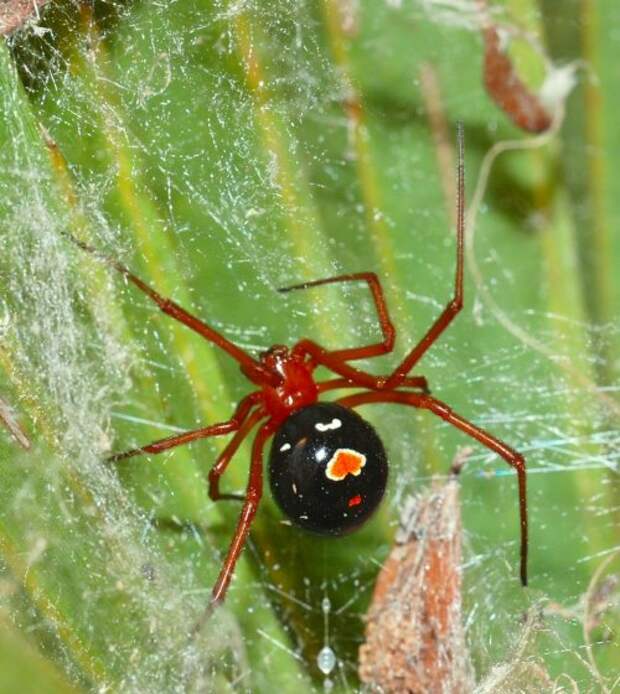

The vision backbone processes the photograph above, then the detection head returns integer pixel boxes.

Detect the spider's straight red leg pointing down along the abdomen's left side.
[211,422,272,604]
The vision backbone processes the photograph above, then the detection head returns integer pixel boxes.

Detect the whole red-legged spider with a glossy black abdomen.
[82,124,528,606]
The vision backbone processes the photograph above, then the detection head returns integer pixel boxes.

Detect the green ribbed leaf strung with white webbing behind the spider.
[0,0,620,692]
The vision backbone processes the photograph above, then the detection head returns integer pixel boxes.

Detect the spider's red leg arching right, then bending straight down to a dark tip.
[337,390,528,586]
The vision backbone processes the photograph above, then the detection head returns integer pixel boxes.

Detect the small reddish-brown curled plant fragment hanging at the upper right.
[482,25,552,133]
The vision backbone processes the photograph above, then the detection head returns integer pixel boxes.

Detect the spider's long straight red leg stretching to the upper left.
[70,236,280,385]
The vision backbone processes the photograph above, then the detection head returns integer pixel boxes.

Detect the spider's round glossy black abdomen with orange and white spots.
[269,403,388,535]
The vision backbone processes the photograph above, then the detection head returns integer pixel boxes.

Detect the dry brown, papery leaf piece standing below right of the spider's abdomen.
[359,477,474,694]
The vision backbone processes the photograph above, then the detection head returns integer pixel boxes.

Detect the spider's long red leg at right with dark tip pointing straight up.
[293,124,465,390]
